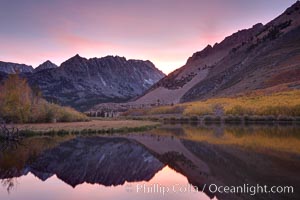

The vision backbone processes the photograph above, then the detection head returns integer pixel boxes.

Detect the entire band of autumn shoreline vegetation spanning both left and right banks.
[0,74,300,141]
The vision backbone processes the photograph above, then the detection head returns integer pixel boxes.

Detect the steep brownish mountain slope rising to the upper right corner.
[132,1,300,105]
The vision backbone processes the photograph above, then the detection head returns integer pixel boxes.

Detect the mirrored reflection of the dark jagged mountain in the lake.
[28,137,164,187]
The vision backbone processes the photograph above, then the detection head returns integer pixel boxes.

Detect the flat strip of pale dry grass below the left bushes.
[16,120,158,132]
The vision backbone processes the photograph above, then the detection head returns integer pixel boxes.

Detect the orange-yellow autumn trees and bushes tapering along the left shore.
[0,74,86,123]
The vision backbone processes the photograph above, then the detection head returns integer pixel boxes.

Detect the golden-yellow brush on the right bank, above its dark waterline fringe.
[131,90,300,117]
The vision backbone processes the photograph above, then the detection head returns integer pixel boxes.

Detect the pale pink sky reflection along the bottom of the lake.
[0,167,210,200]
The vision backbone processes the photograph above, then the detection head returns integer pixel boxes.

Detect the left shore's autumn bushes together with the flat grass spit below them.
[0,73,159,140]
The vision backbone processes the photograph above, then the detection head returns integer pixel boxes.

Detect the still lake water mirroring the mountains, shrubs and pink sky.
[0,125,300,200]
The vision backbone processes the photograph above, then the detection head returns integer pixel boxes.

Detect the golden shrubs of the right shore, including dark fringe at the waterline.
[123,90,300,124]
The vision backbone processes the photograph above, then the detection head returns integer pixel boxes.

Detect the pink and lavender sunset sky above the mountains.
[0,0,296,74]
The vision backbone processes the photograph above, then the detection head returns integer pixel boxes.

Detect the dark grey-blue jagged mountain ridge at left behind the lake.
[0,54,165,110]
